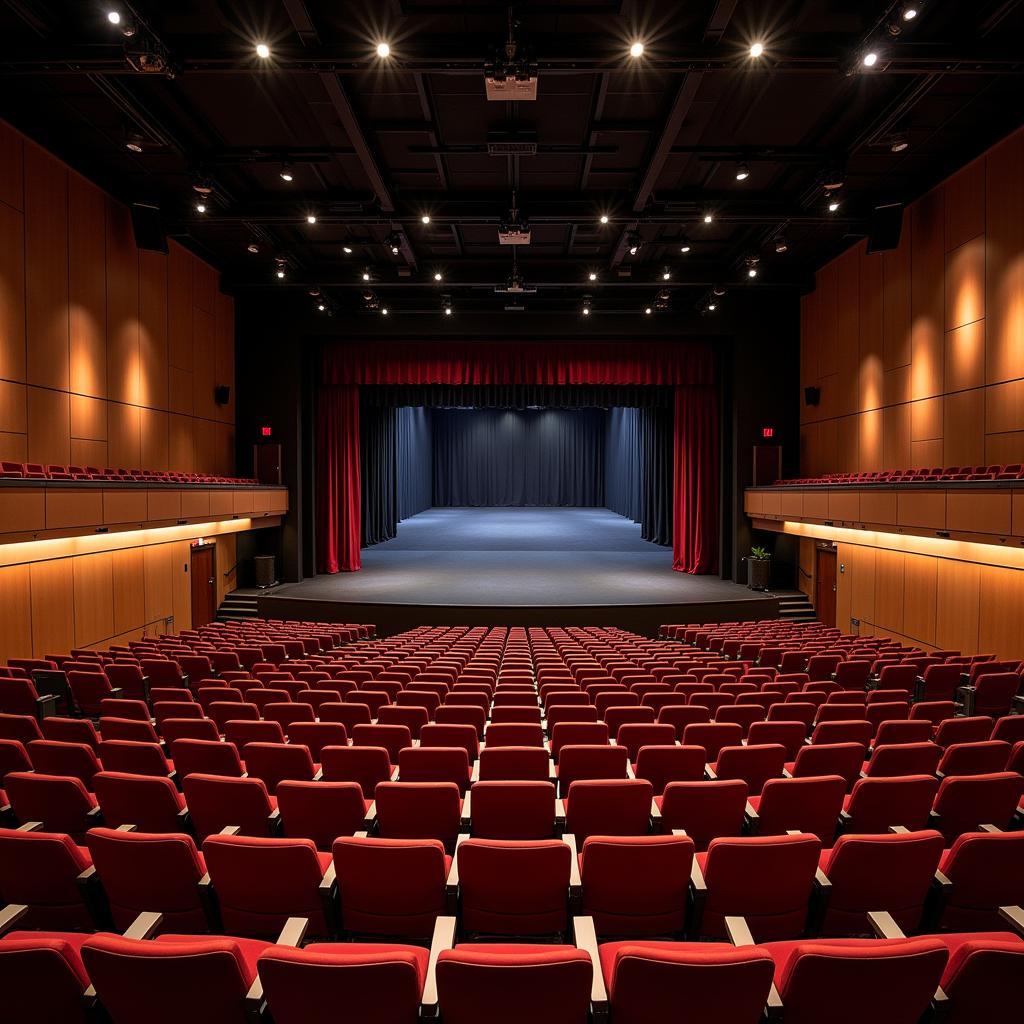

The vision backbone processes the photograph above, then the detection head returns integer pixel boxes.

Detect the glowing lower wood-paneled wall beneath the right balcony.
[836,544,1024,658]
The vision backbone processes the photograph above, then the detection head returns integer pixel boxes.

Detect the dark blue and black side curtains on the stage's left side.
[359,403,433,547]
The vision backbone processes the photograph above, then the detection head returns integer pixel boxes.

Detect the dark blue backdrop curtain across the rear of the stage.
[433,409,604,507]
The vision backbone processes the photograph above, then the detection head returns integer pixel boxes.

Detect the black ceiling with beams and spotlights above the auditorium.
[0,0,1024,313]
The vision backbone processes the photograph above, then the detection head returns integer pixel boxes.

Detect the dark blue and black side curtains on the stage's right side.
[604,408,675,545]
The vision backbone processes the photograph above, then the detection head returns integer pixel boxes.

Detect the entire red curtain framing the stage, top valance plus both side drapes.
[316,341,719,573]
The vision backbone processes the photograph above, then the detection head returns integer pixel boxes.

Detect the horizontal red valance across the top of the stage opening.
[324,341,715,385]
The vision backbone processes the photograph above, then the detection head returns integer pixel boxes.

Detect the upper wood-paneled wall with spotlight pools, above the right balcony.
[801,129,1024,475]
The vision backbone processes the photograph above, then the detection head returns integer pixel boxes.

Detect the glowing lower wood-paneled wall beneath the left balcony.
[0,535,237,663]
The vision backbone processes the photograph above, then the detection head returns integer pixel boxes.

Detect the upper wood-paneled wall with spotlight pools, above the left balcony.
[0,122,234,474]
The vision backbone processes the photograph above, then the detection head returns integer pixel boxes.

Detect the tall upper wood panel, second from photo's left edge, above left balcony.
[25,142,69,391]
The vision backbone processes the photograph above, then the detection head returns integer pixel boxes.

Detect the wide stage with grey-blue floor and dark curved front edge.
[258,508,778,634]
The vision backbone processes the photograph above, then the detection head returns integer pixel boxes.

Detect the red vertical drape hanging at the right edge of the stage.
[672,387,719,573]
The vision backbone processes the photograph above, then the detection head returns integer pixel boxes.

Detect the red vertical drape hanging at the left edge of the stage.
[316,386,362,572]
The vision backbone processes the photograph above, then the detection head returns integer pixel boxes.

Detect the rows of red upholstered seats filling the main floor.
[0,624,1024,1021]
